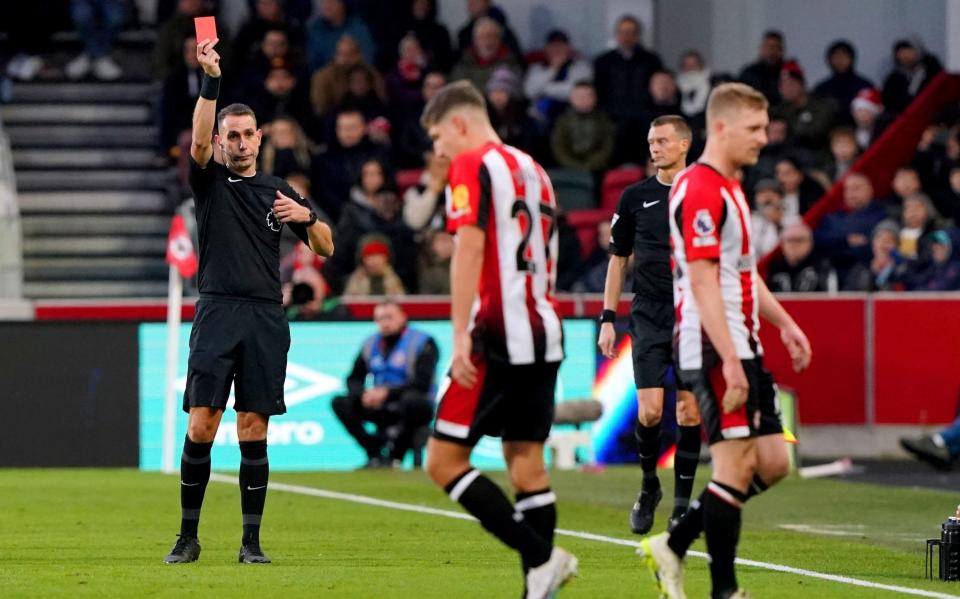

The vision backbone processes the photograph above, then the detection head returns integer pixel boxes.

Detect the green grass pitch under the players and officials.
[0,468,960,599]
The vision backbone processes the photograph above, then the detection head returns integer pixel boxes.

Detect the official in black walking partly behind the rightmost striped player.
[598,115,700,534]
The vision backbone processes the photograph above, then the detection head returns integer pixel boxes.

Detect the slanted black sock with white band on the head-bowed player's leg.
[444,468,552,568]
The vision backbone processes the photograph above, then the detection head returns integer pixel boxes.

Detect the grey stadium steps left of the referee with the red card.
[8,60,177,299]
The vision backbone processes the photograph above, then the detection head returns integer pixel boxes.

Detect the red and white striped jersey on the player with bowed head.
[447,143,563,364]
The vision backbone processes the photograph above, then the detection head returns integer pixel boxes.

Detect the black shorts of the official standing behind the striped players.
[630,296,689,391]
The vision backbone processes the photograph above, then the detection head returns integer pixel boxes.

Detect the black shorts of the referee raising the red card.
[183,298,290,416]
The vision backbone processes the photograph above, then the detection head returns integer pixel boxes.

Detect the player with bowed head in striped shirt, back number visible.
[421,81,577,599]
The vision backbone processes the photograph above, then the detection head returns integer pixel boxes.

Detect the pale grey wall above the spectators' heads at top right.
[438,0,948,83]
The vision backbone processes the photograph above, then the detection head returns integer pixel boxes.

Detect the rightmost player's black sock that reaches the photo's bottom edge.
[703,480,747,599]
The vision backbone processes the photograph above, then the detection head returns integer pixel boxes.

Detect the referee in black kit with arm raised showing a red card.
[164,39,333,564]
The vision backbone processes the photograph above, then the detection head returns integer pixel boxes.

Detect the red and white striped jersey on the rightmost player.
[670,163,763,370]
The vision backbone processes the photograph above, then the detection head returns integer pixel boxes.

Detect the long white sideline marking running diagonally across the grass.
[210,473,960,599]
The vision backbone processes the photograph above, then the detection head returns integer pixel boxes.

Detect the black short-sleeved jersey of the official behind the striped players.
[609,176,673,305]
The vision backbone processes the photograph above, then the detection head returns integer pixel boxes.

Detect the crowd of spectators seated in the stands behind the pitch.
[146,0,960,311]
